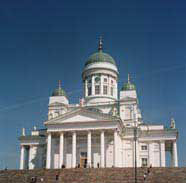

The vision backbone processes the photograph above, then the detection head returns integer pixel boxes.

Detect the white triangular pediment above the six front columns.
[45,109,116,124]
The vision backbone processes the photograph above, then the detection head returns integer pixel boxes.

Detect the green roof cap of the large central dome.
[85,50,116,66]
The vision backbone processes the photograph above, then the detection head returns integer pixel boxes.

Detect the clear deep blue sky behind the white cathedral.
[0,0,186,168]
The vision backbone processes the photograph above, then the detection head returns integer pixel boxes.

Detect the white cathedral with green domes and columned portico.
[19,39,178,169]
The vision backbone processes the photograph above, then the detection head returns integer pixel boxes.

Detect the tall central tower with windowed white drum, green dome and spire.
[82,38,119,104]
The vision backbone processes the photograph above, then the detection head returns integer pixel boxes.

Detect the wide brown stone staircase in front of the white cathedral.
[0,168,186,183]
